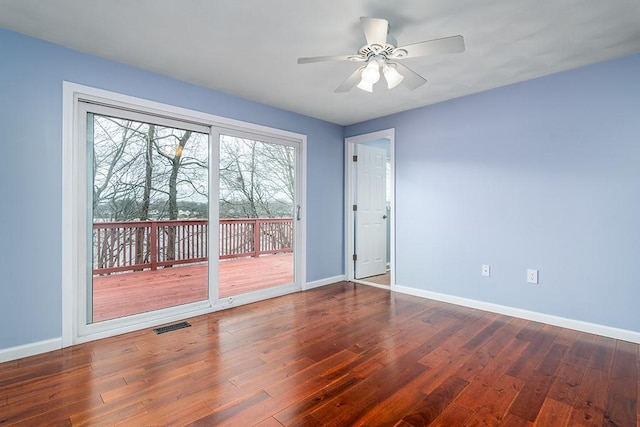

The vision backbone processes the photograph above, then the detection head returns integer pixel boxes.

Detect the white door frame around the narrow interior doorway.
[344,128,396,289]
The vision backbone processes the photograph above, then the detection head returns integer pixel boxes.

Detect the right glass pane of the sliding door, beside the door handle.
[218,135,296,298]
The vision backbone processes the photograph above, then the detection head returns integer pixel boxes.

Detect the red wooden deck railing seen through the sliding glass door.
[93,218,293,274]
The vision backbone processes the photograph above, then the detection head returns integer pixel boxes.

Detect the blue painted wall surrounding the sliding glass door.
[0,29,344,350]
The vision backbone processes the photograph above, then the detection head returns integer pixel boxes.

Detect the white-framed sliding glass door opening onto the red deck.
[63,83,306,345]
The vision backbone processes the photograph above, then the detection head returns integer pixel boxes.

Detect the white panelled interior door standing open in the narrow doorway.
[355,144,388,279]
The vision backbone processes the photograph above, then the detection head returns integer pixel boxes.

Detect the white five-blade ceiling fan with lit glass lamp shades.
[298,16,464,92]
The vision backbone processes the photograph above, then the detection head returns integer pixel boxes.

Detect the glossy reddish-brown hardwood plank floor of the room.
[0,282,640,427]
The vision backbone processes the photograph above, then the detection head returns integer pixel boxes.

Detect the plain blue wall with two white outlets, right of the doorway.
[345,55,640,331]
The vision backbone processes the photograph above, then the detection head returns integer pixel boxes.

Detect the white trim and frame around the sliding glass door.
[62,81,307,347]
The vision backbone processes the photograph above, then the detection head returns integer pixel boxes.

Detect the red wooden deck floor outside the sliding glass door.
[93,253,293,322]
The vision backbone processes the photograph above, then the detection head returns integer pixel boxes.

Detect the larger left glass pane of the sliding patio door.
[87,114,209,323]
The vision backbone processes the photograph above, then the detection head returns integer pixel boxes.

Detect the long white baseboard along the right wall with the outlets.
[392,285,640,344]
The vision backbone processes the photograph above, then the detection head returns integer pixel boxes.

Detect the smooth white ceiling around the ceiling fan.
[0,0,640,125]
